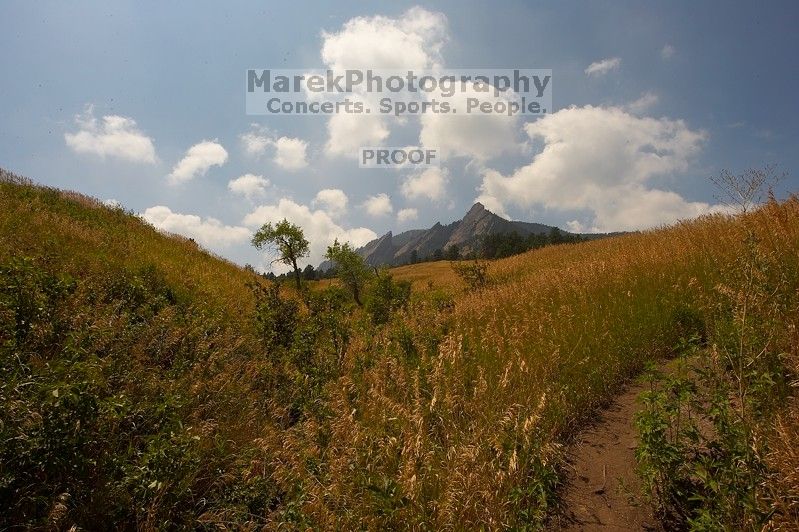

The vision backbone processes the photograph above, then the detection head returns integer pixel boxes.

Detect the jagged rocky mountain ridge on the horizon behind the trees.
[319,203,603,270]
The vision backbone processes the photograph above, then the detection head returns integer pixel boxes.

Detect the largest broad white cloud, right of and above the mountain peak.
[478,105,717,231]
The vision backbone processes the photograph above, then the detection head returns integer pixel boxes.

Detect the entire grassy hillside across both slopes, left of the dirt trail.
[0,172,799,529]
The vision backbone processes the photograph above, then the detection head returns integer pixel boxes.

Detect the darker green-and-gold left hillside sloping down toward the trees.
[0,178,273,528]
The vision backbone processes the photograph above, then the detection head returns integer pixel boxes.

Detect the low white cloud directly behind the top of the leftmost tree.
[243,198,377,264]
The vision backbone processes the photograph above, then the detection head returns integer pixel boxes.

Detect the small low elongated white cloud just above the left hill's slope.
[142,205,252,251]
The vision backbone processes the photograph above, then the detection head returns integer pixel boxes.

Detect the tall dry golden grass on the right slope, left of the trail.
[282,199,799,528]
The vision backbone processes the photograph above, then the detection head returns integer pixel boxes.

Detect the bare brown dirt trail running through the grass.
[551,382,660,531]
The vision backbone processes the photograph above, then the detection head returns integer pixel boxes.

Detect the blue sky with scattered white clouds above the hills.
[0,1,799,267]
